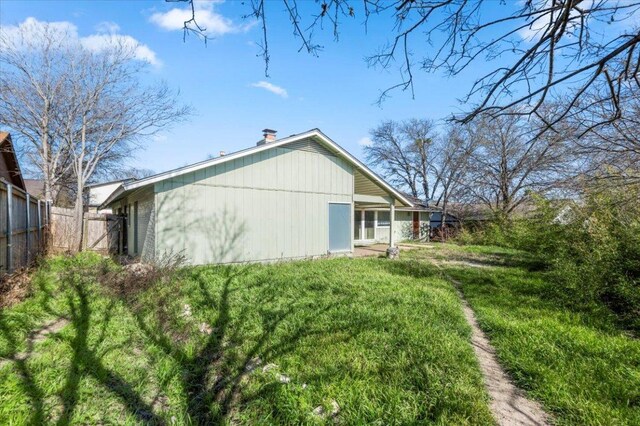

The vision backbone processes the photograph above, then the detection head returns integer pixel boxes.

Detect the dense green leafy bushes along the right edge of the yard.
[458,188,640,332]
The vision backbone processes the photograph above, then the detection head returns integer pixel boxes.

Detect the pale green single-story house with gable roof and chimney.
[101,129,428,264]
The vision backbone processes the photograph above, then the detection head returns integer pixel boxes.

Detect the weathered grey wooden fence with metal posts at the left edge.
[0,180,50,273]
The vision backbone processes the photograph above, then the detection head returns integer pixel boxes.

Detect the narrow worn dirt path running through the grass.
[436,264,550,426]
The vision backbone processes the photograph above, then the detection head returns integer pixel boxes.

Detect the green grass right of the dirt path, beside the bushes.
[405,245,640,425]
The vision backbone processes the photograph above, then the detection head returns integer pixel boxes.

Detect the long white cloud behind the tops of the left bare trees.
[0,17,162,66]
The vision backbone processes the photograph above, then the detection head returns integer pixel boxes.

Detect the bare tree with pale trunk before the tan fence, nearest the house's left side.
[59,39,189,250]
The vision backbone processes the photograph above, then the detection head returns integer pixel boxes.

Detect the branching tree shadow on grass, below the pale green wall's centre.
[129,266,344,424]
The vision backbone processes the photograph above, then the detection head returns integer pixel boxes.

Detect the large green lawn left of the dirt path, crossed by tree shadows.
[0,255,492,425]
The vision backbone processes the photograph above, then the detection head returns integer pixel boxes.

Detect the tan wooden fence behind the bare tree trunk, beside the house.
[51,207,122,254]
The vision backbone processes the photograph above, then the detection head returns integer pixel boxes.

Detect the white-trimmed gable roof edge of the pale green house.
[101,129,413,207]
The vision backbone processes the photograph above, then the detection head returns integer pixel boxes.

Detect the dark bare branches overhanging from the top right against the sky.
[178,0,640,136]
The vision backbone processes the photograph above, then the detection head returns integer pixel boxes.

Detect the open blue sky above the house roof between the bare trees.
[0,0,604,176]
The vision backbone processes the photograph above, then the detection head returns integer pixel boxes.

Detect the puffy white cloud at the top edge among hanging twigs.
[149,1,255,36]
